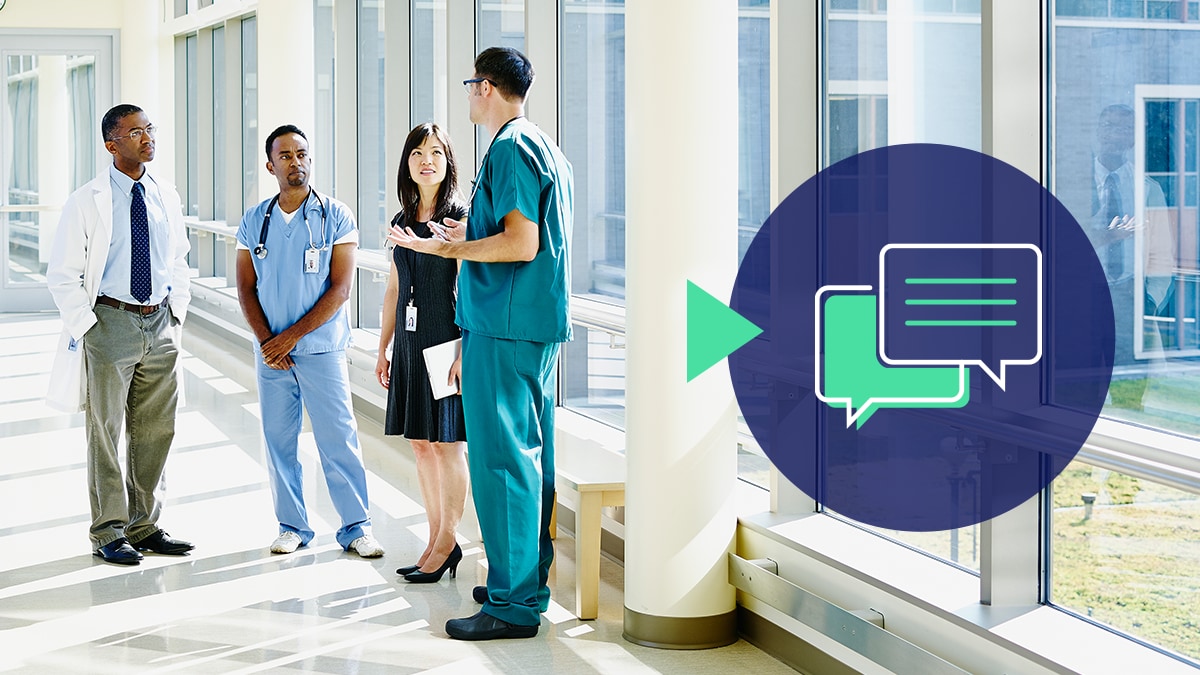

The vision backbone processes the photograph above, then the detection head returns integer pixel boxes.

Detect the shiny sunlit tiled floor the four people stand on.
[0,315,791,675]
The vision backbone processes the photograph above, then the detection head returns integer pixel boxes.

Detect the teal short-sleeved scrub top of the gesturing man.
[456,118,574,342]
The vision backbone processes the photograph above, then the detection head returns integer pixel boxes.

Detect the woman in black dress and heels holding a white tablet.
[376,123,468,583]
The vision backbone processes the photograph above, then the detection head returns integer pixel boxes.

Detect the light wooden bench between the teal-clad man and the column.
[550,431,625,619]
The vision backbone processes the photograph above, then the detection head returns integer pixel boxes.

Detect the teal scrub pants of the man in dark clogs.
[462,330,559,626]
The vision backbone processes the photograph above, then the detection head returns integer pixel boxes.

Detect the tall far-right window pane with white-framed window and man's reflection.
[1050,12,1200,435]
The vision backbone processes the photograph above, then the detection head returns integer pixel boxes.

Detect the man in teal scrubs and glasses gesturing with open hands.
[388,47,572,640]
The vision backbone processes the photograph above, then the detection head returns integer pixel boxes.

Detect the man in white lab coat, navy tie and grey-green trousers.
[46,104,192,565]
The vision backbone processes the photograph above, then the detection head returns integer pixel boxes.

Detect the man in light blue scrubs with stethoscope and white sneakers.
[238,125,383,557]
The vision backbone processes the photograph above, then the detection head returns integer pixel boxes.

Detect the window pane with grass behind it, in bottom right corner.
[1050,461,1200,662]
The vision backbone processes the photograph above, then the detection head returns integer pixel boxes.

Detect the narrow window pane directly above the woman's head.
[408,0,449,126]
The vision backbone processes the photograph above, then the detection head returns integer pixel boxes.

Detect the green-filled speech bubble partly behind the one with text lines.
[815,286,971,428]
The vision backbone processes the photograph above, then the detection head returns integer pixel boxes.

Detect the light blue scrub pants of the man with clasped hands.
[254,350,371,549]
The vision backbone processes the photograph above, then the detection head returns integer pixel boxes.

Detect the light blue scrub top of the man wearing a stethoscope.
[238,191,359,354]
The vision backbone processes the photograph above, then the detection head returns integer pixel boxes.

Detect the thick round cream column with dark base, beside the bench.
[624,0,738,649]
